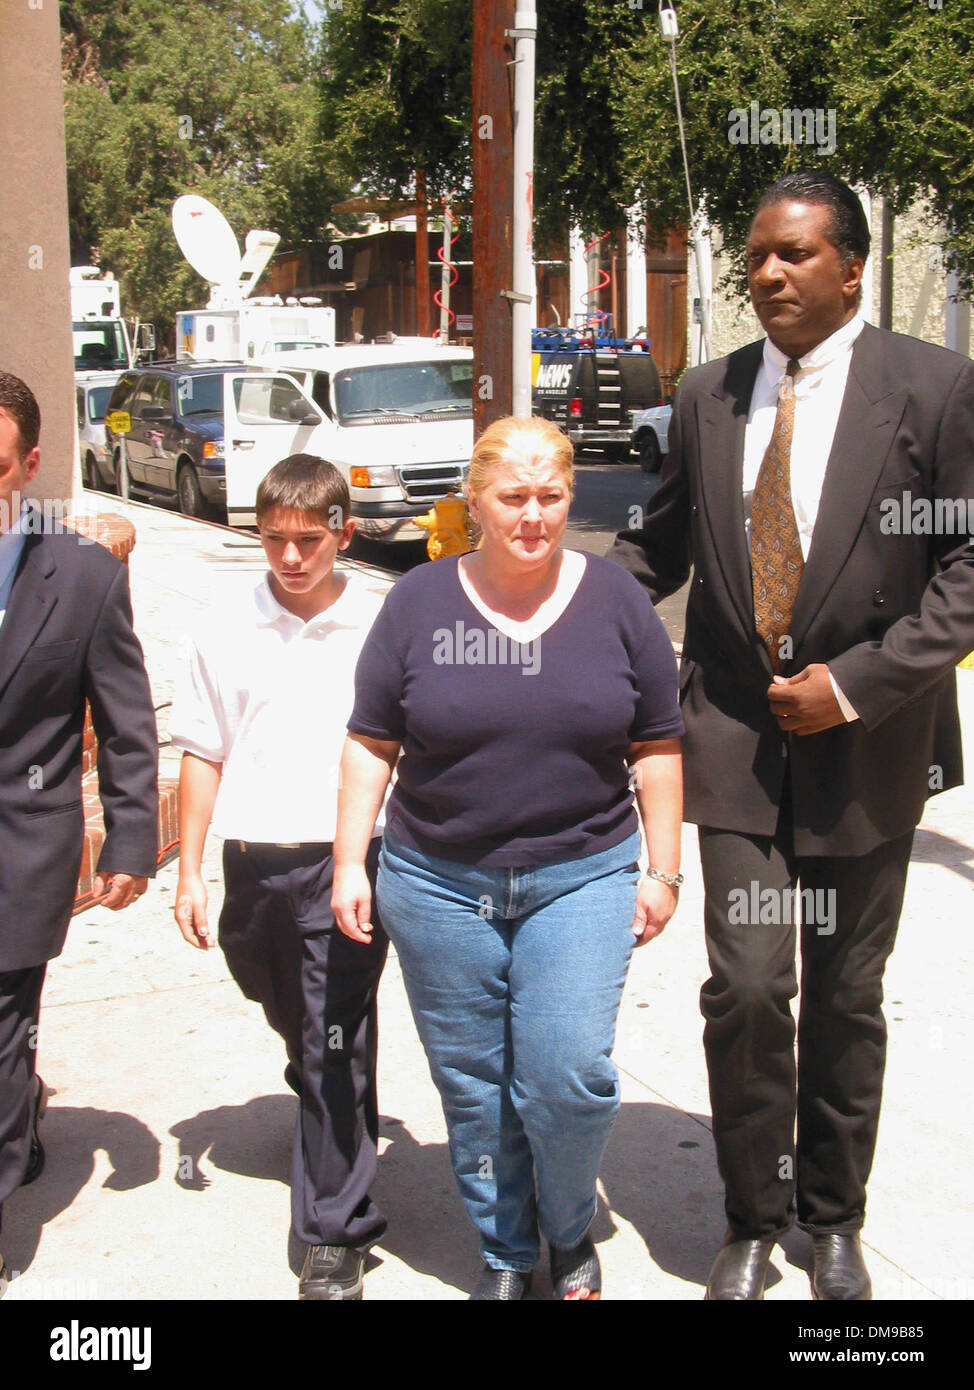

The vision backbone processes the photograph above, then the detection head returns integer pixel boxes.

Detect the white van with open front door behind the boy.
[224,339,474,541]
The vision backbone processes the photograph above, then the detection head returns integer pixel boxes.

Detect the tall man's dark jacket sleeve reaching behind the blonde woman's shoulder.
[607,380,692,605]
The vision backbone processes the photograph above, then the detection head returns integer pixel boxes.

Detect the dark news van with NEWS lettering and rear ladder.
[532,314,663,463]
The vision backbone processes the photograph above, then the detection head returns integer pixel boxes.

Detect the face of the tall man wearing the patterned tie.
[748,202,863,357]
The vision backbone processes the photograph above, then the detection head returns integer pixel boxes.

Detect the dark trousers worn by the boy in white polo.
[220,840,389,1251]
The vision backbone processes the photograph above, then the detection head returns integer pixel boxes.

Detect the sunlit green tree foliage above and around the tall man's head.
[613,0,974,293]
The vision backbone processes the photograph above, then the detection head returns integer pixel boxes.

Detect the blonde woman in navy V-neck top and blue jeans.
[332,418,684,1300]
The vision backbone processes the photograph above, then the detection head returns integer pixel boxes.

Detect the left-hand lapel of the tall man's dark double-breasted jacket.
[698,339,771,650]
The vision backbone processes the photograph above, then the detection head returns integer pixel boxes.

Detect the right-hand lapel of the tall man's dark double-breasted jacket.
[791,324,907,646]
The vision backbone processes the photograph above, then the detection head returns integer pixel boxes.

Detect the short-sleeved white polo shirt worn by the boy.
[170,575,382,844]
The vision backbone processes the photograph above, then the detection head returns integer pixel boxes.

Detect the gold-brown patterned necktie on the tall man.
[750,357,804,674]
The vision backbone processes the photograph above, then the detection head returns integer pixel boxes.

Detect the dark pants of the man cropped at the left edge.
[0,962,47,1234]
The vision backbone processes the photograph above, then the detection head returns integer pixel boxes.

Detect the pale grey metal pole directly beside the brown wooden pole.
[511,0,538,418]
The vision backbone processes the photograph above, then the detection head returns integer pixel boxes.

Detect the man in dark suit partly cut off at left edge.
[0,371,158,1293]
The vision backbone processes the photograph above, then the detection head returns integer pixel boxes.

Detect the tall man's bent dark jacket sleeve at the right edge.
[828,363,974,730]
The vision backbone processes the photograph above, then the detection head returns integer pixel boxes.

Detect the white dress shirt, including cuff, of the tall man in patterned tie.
[743,314,864,720]
